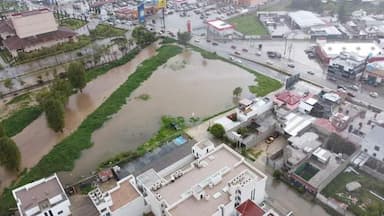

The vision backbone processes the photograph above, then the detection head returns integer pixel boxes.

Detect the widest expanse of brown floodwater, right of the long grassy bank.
[60,51,255,184]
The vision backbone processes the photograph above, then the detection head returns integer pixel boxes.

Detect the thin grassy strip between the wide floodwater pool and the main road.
[190,45,283,97]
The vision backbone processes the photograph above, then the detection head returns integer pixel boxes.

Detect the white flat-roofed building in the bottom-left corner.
[12,174,71,216]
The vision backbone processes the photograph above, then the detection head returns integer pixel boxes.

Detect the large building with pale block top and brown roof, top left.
[0,8,76,57]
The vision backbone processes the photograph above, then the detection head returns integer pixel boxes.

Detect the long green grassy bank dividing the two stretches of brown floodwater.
[0,45,182,215]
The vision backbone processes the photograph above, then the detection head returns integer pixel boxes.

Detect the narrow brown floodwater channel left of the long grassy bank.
[0,45,156,192]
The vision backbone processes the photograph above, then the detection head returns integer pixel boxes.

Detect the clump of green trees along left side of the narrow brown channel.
[37,62,87,132]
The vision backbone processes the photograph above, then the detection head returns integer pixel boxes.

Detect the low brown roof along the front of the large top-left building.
[3,28,76,50]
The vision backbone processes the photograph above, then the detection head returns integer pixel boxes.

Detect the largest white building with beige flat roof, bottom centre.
[136,144,267,216]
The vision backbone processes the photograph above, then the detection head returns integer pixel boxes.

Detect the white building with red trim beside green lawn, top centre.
[207,20,234,40]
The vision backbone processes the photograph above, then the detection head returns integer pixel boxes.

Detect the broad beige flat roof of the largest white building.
[154,144,266,216]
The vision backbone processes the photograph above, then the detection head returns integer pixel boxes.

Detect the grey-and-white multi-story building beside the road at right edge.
[327,53,366,80]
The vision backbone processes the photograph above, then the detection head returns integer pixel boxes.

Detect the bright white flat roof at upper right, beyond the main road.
[288,10,325,28]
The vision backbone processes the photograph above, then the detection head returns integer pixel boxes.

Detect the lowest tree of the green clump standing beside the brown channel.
[43,96,64,132]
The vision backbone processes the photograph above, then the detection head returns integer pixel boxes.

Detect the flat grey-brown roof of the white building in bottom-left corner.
[13,174,67,212]
